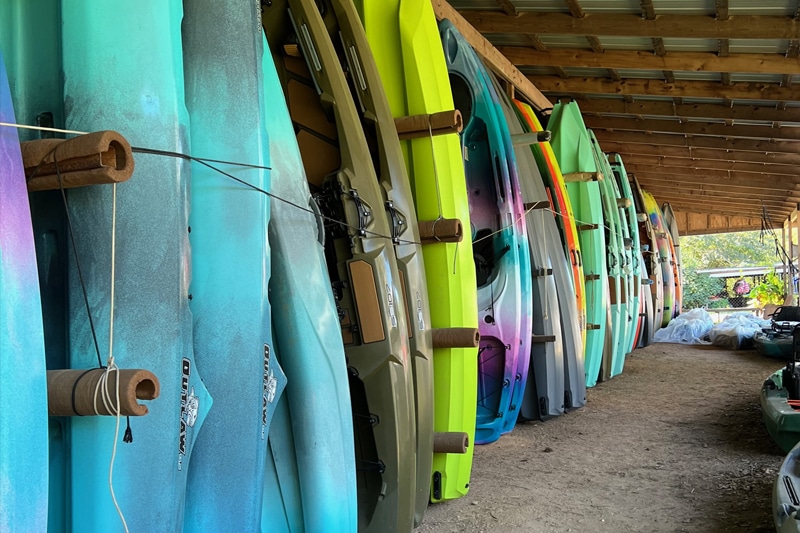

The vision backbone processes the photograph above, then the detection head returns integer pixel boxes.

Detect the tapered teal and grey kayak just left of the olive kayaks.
[261,29,358,532]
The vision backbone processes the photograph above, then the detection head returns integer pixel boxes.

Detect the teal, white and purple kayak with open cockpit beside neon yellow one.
[439,20,528,444]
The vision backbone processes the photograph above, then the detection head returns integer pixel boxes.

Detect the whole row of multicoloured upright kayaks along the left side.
[0,0,681,532]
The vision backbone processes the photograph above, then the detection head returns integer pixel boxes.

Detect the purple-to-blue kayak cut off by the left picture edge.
[0,54,48,531]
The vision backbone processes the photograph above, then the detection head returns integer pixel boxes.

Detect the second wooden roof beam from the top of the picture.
[498,46,800,74]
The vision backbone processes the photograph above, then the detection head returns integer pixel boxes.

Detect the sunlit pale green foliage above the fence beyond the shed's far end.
[680,231,776,270]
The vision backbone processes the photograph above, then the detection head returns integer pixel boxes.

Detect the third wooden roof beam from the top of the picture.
[530,77,800,101]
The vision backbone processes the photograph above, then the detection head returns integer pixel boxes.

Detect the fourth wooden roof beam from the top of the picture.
[577,98,800,123]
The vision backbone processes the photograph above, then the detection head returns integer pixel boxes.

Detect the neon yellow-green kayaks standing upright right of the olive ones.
[355,0,478,502]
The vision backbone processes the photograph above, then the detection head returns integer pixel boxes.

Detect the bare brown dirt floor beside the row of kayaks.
[417,344,783,533]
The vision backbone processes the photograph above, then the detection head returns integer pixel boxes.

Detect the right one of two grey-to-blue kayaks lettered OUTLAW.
[181,0,280,533]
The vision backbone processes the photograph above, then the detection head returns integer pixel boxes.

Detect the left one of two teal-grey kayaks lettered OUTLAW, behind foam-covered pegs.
[62,0,212,531]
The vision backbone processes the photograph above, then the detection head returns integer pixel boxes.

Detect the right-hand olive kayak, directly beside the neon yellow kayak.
[317,0,433,524]
